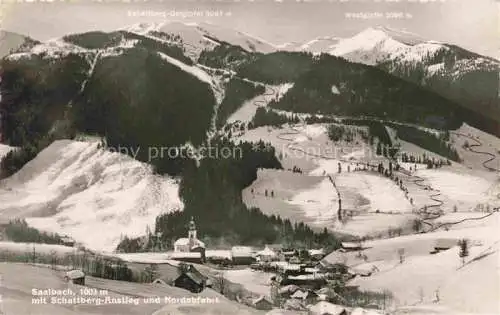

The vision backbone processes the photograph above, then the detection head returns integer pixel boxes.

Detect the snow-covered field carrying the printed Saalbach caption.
[0,263,264,315]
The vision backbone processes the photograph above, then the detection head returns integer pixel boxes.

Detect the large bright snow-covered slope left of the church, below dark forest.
[0,140,183,250]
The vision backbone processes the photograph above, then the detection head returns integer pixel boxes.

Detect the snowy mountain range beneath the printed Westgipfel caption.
[285,27,500,123]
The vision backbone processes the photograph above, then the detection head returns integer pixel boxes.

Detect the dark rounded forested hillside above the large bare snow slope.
[74,48,215,174]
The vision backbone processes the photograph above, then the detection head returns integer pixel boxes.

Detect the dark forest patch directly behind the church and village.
[118,139,339,251]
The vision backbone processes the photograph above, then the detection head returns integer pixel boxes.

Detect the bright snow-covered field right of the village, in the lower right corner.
[326,213,500,315]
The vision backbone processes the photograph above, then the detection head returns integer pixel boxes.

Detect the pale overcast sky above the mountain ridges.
[0,0,500,58]
